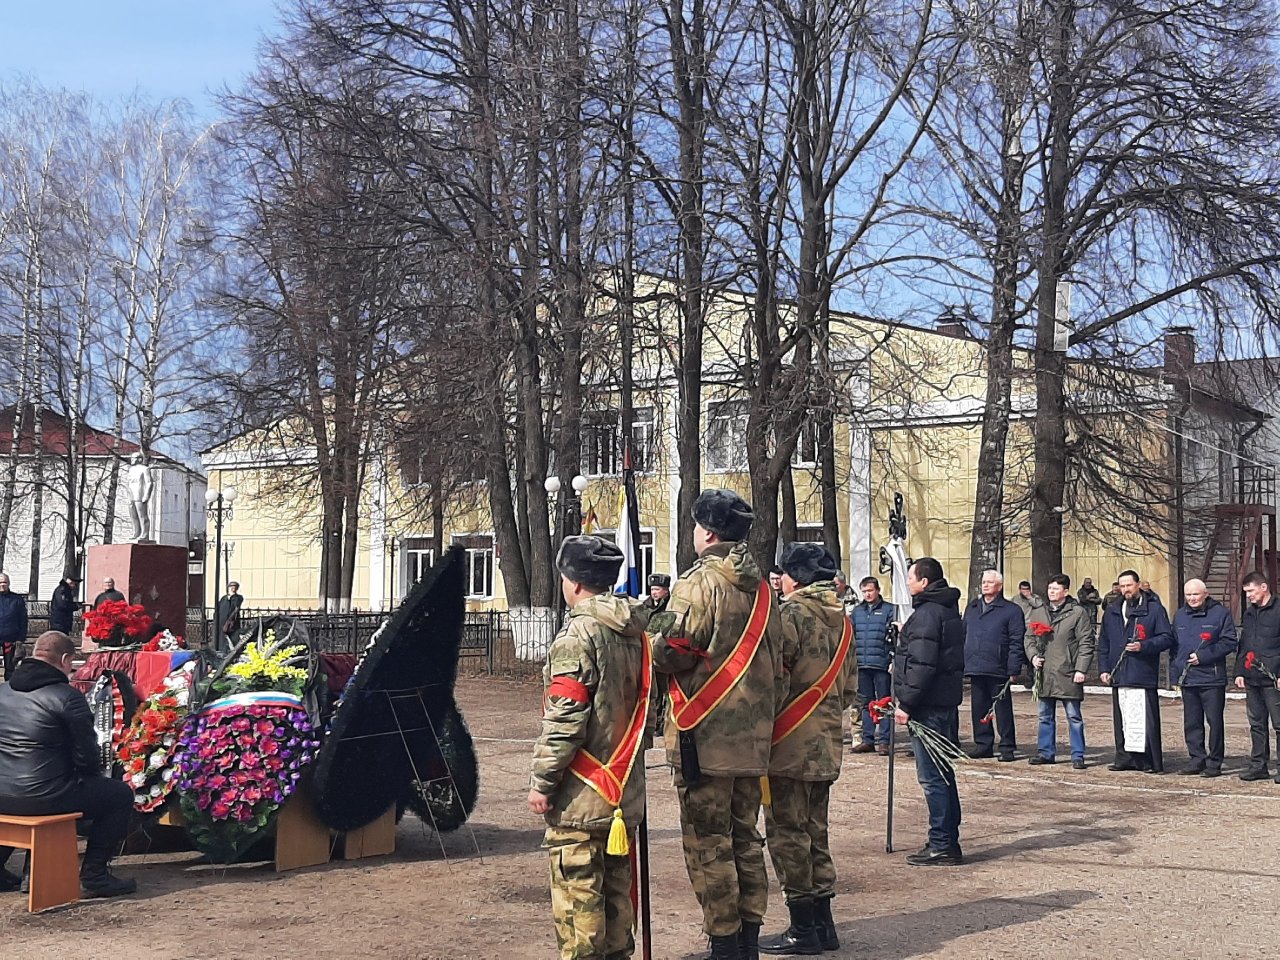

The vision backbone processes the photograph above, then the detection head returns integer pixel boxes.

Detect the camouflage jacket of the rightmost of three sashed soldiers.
[769,580,858,781]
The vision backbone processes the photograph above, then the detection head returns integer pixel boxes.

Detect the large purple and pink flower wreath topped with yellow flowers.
[175,630,319,863]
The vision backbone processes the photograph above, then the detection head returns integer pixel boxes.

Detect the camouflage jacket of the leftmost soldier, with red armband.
[531,594,646,831]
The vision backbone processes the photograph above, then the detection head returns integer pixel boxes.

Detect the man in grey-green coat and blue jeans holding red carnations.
[1027,573,1094,771]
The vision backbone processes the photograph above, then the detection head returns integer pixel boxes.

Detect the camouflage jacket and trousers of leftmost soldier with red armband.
[531,594,646,960]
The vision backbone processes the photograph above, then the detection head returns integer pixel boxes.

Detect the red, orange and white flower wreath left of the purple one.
[116,663,195,813]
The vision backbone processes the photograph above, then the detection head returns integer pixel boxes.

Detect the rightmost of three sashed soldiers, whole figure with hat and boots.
[760,543,858,956]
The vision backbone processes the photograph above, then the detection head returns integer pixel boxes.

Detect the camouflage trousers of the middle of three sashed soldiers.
[675,769,769,937]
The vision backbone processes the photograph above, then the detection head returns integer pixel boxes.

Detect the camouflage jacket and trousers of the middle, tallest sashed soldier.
[649,541,785,937]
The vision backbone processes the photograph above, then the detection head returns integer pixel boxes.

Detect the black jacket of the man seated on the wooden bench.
[0,658,101,800]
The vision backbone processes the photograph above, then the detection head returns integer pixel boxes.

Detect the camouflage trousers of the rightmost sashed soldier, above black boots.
[764,777,836,904]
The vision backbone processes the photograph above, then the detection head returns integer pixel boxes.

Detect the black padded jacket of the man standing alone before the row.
[893,577,964,714]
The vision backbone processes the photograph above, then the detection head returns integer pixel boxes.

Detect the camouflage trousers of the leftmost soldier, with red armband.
[543,827,635,960]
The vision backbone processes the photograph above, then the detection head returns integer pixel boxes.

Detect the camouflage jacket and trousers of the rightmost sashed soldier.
[764,581,858,904]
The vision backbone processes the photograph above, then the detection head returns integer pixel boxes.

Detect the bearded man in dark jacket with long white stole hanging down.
[1098,570,1174,773]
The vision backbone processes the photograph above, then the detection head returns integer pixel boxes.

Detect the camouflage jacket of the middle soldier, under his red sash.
[649,543,786,777]
